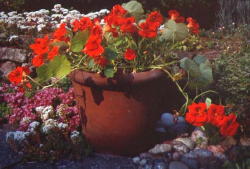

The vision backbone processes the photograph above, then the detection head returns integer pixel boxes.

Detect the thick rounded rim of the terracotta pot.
[69,69,167,89]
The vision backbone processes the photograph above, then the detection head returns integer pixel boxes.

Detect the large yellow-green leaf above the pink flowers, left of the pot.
[36,55,71,82]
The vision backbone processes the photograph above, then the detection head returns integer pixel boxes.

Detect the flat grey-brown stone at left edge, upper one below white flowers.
[0,47,27,63]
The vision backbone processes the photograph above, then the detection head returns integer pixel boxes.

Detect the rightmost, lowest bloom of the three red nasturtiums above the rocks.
[220,113,240,136]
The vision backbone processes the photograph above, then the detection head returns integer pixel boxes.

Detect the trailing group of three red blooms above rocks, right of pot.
[186,103,239,136]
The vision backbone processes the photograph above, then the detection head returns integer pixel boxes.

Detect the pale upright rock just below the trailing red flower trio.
[191,128,208,148]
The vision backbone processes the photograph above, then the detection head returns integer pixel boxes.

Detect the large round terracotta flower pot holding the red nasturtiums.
[70,70,183,155]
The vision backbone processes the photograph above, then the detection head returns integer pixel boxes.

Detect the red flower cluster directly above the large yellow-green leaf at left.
[30,34,59,67]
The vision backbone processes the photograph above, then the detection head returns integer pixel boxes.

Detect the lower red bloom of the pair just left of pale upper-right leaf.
[138,22,157,38]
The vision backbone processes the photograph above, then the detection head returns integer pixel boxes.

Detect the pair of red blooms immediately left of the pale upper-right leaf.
[138,11,163,38]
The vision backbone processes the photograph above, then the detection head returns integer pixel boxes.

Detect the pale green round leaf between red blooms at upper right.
[160,20,188,41]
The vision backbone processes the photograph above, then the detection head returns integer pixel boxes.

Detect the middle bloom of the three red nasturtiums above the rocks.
[207,104,225,127]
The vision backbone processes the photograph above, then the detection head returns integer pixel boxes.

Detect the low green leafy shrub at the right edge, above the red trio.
[213,45,250,114]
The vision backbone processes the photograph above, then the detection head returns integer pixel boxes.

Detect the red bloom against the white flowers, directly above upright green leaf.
[72,17,93,32]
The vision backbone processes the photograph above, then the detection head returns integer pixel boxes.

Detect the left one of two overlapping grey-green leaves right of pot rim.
[180,57,201,78]
